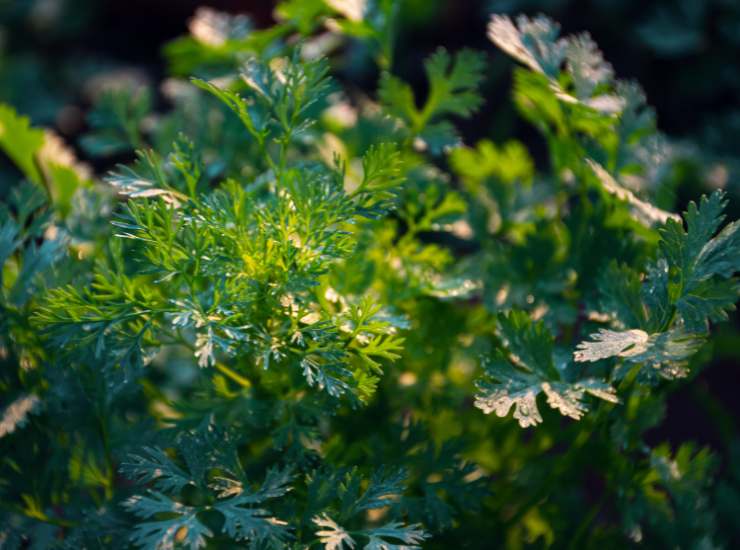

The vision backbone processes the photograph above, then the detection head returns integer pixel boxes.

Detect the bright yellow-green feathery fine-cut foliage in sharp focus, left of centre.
[40,148,402,399]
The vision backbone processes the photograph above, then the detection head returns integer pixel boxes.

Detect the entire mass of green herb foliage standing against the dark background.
[0,5,740,550]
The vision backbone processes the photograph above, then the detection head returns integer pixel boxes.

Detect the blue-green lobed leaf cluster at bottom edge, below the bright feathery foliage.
[121,425,291,549]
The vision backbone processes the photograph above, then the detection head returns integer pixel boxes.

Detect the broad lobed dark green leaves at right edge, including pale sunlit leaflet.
[575,191,740,378]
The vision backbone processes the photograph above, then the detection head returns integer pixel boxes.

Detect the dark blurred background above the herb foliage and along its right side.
[0,0,740,458]
